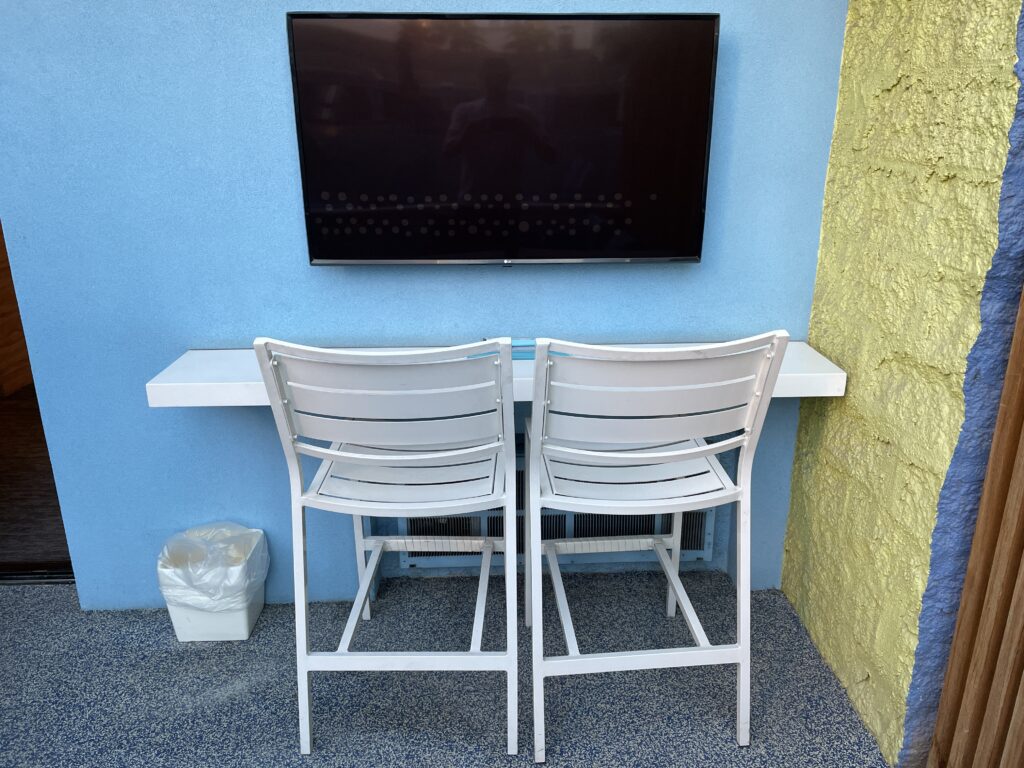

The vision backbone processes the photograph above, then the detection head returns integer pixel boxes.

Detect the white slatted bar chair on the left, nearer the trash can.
[254,339,518,755]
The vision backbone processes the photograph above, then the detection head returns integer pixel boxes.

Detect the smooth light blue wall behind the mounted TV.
[0,0,846,608]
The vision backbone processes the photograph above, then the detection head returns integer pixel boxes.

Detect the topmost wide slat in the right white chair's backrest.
[548,347,767,387]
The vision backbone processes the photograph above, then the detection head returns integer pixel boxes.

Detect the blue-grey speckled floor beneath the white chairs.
[0,572,885,768]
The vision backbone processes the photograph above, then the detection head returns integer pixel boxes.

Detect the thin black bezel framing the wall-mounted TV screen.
[285,11,721,266]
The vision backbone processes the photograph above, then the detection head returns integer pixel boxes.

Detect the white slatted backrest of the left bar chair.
[253,338,515,495]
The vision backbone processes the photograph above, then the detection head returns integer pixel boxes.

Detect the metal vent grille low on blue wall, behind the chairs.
[400,470,715,567]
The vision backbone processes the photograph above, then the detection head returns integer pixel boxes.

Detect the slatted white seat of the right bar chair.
[541,440,738,509]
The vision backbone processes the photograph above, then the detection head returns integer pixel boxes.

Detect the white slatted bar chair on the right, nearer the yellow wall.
[524,331,788,763]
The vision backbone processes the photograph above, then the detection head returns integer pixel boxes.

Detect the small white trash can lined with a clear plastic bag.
[157,522,270,642]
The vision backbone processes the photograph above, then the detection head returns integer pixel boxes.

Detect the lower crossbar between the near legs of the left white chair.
[300,651,514,672]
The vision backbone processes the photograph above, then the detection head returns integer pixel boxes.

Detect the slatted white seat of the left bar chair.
[304,446,505,517]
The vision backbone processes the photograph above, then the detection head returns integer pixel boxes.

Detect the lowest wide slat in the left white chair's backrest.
[292,411,501,446]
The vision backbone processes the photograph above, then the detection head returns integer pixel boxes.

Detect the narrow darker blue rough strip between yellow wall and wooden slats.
[899,3,1024,766]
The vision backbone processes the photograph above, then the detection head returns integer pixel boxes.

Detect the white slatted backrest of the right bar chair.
[532,331,788,483]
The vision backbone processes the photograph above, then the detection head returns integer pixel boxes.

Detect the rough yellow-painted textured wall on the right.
[782,0,1021,763]
